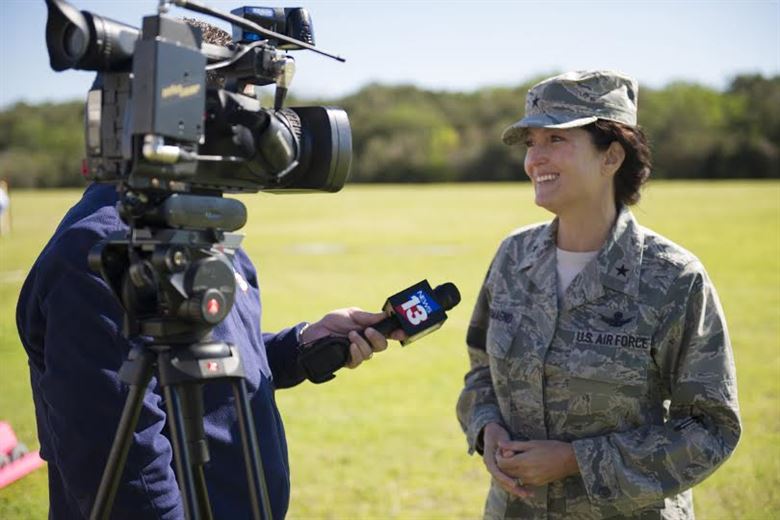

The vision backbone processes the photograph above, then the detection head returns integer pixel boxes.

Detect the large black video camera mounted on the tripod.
[46,0,352,194]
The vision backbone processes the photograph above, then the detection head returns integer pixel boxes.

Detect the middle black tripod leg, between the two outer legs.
[163,385,200,520]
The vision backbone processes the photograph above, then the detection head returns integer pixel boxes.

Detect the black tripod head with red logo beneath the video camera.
[89,189,246,345]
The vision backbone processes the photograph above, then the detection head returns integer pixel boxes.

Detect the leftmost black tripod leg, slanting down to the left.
[90,349,156,520]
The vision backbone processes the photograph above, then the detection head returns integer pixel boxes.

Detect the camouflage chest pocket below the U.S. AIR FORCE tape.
[567,344,650,435]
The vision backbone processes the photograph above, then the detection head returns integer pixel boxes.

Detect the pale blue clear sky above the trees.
[0,0,780,108]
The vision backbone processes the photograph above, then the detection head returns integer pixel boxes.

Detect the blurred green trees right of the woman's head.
[640,76,780,179]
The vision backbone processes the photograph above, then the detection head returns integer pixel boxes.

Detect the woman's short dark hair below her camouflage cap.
[582,119,652,207]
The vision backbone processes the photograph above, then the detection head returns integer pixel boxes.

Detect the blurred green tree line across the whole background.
[0,75,780,188]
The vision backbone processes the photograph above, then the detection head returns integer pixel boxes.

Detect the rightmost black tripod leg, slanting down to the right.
[233,379,273,520]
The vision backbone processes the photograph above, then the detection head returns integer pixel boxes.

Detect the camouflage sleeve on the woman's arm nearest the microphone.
[457,274,503,454]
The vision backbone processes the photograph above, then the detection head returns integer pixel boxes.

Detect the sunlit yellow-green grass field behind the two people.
[0,182,780,520]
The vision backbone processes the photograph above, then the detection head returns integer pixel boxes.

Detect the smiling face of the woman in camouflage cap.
[525,128,622,218]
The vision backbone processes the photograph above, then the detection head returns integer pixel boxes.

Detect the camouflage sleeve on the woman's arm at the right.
[573,262,741,512]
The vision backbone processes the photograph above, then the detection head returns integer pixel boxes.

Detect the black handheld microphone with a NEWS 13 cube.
[298,280,460,383]
